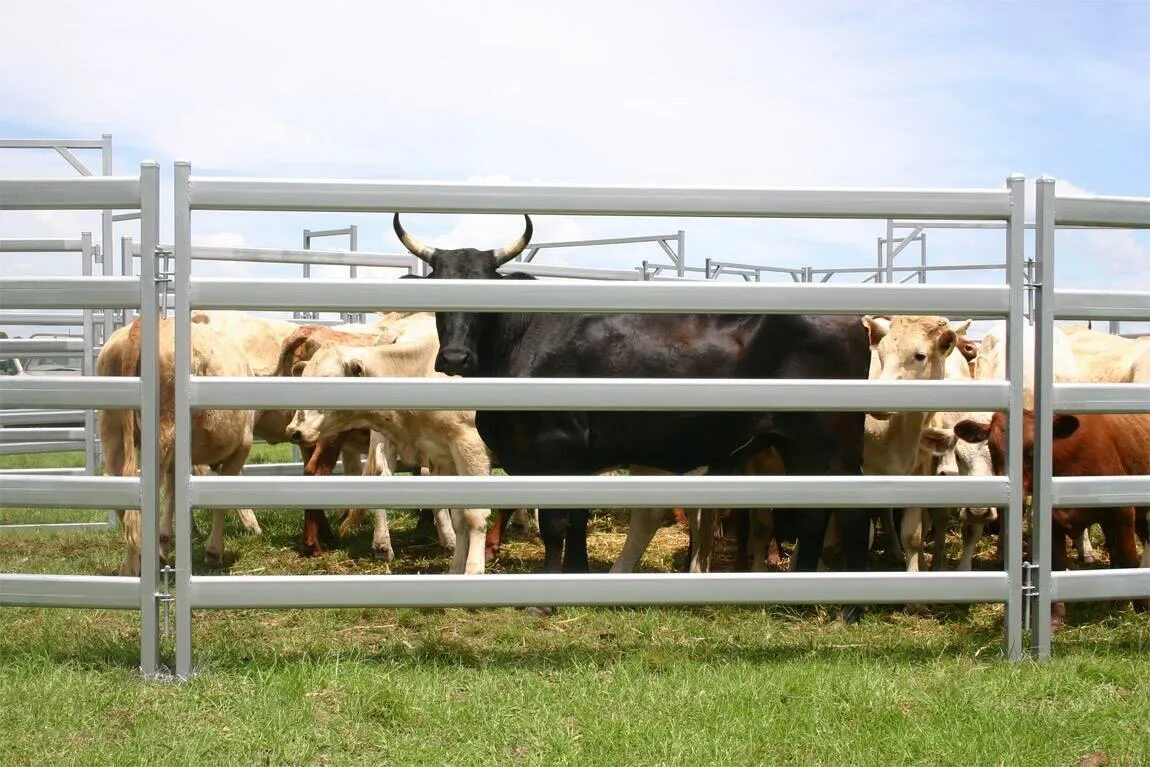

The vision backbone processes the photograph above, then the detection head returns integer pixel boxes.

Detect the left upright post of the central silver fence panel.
[171,161,192,678]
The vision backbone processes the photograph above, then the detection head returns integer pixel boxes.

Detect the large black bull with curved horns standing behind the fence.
[393,214,871,573]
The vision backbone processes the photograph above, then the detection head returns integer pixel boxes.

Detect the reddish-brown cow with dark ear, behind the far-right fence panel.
[955,411,1150,629]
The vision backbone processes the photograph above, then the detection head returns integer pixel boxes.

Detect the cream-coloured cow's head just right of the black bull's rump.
[863,315,969,420]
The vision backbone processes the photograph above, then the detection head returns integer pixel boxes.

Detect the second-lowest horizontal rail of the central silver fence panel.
[190,476,1009,508]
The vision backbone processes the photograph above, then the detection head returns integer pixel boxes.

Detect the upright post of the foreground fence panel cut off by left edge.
[137,162,162,677]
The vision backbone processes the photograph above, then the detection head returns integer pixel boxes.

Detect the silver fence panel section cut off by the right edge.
[1032,178,1150,660]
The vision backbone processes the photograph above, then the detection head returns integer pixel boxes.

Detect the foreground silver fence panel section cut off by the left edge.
[0,163,160,674]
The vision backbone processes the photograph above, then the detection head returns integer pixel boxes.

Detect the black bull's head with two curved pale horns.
[393,213,532,376]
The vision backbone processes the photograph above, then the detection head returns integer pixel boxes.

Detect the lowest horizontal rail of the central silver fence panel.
[190,573,1007,608]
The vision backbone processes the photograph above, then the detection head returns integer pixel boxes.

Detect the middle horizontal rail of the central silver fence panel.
[187,376,1010,412]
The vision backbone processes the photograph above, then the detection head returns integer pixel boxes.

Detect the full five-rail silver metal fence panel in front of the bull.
[174,162,1025,676]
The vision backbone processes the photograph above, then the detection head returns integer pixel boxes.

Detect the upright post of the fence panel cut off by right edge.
[1030,178,1066,661]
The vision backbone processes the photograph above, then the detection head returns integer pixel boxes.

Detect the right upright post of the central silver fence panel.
[1002,176,1026,660]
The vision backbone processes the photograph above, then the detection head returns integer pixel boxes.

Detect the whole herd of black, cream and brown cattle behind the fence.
[97,214,1150,622]
